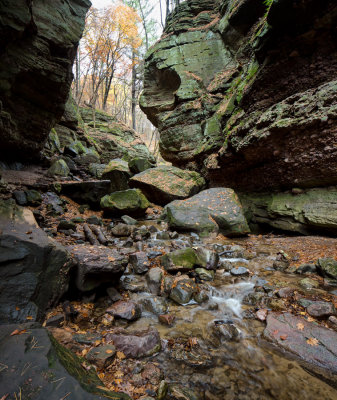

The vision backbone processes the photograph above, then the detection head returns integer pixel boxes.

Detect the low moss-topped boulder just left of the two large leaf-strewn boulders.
[100,189,150,215]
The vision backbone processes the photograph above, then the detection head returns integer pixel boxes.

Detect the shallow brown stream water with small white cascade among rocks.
[122,230,337,400]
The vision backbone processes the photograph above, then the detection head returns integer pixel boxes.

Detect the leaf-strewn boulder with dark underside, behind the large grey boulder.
[129,166,205,205]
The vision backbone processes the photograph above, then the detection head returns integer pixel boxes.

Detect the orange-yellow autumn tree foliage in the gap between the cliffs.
[75,2,142,110]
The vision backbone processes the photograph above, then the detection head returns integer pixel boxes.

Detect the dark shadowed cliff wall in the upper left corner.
[0,0,91,159]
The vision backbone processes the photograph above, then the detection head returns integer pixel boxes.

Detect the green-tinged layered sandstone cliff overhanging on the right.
[140,0,337,192]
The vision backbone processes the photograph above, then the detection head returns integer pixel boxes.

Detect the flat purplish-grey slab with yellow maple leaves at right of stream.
[263,313,337,386]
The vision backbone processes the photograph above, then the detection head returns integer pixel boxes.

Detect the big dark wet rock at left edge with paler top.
[0,200,71,324]
